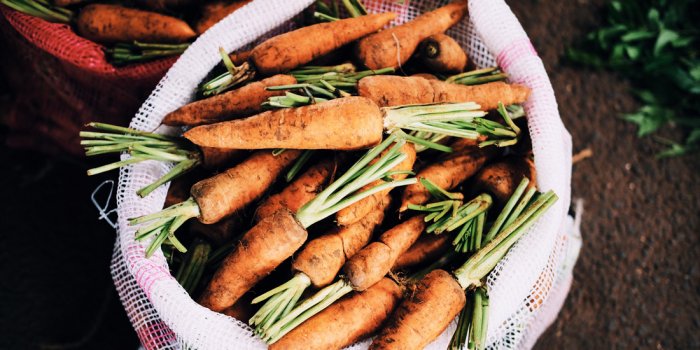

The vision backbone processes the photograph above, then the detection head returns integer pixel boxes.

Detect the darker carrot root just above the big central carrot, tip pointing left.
[162,74,297,126]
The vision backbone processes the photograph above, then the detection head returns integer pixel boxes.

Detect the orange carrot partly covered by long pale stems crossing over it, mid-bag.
[336,143,416,225]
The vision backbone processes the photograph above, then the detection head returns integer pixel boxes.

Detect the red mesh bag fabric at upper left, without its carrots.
[0,5,177,155]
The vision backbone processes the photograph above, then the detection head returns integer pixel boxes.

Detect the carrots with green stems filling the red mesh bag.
[0,0,260,65]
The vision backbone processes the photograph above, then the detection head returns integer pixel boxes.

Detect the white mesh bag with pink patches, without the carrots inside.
[111,0,580,349]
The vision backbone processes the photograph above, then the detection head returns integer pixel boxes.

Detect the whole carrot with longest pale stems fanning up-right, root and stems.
[194,135,415,316]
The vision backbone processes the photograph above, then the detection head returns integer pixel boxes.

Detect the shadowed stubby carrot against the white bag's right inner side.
[474,157,537,203]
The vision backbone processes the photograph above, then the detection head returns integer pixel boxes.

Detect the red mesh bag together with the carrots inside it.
[0,0,258,154]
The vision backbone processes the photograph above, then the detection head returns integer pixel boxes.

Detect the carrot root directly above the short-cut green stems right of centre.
[399,139,494,211]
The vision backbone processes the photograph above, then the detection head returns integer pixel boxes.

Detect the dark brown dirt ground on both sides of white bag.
[0,0,700,349]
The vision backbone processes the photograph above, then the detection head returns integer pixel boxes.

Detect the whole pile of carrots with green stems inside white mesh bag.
[82,1,557,349]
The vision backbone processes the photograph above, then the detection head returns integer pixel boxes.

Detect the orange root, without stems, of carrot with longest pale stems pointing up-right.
[199,209,307,311]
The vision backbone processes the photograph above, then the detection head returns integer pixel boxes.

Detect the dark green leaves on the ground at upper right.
[566,0,700,157]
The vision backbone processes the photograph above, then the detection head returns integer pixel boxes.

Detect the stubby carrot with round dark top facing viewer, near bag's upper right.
[419,33,467,74]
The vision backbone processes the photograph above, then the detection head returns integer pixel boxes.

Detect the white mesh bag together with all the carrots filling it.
[91,0,580,349]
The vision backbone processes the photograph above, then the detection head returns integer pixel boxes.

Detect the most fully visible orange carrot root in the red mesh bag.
[76,4,196,43]
